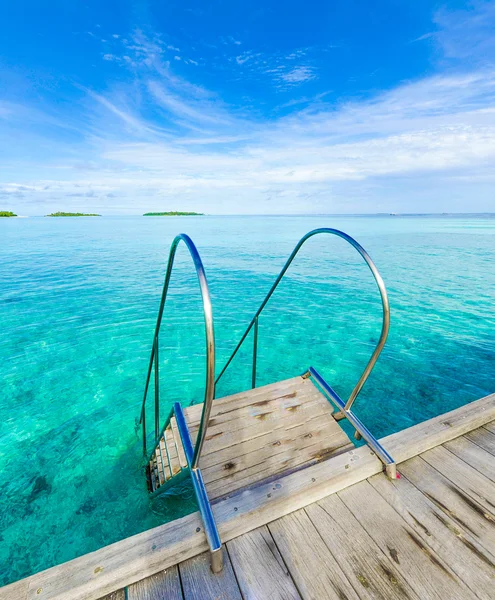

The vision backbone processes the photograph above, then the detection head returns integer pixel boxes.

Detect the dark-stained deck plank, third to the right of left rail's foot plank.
[305,494,419,600]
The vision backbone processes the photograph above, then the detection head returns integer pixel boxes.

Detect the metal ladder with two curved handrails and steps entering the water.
[139,228,397,573]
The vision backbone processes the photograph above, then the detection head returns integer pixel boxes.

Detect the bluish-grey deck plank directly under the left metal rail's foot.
[179,550,242,600]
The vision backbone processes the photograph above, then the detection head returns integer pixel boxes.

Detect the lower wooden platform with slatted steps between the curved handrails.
[150,377,353,501]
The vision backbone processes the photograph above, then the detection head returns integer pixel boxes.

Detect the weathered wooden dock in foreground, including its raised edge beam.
[0,395,495,600]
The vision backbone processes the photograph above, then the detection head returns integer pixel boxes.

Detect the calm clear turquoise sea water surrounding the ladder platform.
[0,217,495,584]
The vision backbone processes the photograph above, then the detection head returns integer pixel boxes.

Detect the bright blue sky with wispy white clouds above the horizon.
[0,0,495,215]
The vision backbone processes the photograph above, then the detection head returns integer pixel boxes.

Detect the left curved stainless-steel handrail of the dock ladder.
[139,233,215,469]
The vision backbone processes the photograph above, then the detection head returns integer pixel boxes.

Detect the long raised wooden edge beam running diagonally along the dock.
[17,395,495,600]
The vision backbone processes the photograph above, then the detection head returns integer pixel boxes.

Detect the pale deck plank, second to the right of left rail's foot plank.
[268,510,359,600]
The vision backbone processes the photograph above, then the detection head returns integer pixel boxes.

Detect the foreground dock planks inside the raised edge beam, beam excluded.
[105,422,495,600]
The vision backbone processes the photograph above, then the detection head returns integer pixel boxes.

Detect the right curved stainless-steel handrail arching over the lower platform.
[215,227,390,409]
